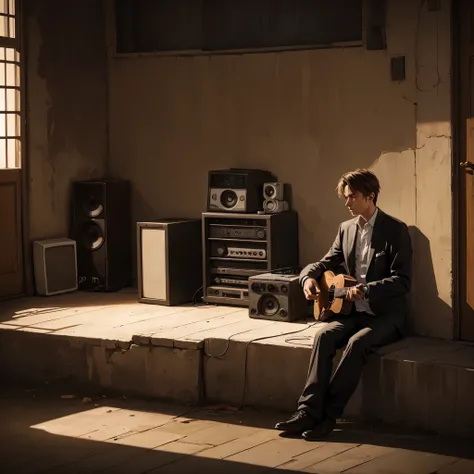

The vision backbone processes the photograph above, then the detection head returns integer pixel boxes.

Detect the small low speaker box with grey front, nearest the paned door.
[33,238,78,296]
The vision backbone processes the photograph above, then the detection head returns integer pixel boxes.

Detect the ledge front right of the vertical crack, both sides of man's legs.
[204,337,474,437]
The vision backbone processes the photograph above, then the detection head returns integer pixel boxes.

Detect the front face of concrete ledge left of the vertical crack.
[0,331,202,404]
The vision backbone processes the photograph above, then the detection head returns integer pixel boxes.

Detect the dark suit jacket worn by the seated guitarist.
[300,209,412,324]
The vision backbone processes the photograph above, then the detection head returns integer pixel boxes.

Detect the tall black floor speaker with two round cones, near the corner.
[71,179,132,291]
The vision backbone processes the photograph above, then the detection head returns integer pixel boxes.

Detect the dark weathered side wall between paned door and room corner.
[23,0,108,240]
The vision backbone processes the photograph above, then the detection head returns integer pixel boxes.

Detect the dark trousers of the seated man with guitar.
[298,311,401,420]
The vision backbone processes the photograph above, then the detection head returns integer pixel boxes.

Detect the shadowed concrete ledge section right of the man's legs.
[360,338,474,437]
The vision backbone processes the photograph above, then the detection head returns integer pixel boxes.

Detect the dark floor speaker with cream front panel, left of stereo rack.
[137,218,202,306]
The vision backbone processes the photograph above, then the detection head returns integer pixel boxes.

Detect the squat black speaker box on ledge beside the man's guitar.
[248,273,308,321]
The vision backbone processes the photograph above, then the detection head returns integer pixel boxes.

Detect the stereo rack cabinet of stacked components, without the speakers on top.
[203,211,298,306]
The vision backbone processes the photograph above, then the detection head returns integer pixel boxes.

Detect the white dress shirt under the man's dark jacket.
[354,208,379,314]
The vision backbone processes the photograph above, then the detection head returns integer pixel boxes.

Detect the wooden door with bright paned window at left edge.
[0,0,24,300]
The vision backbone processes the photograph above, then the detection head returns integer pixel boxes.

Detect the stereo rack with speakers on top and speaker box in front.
[202,168,307,321]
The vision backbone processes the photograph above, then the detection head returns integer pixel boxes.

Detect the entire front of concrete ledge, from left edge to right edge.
[0,330,474,437]
